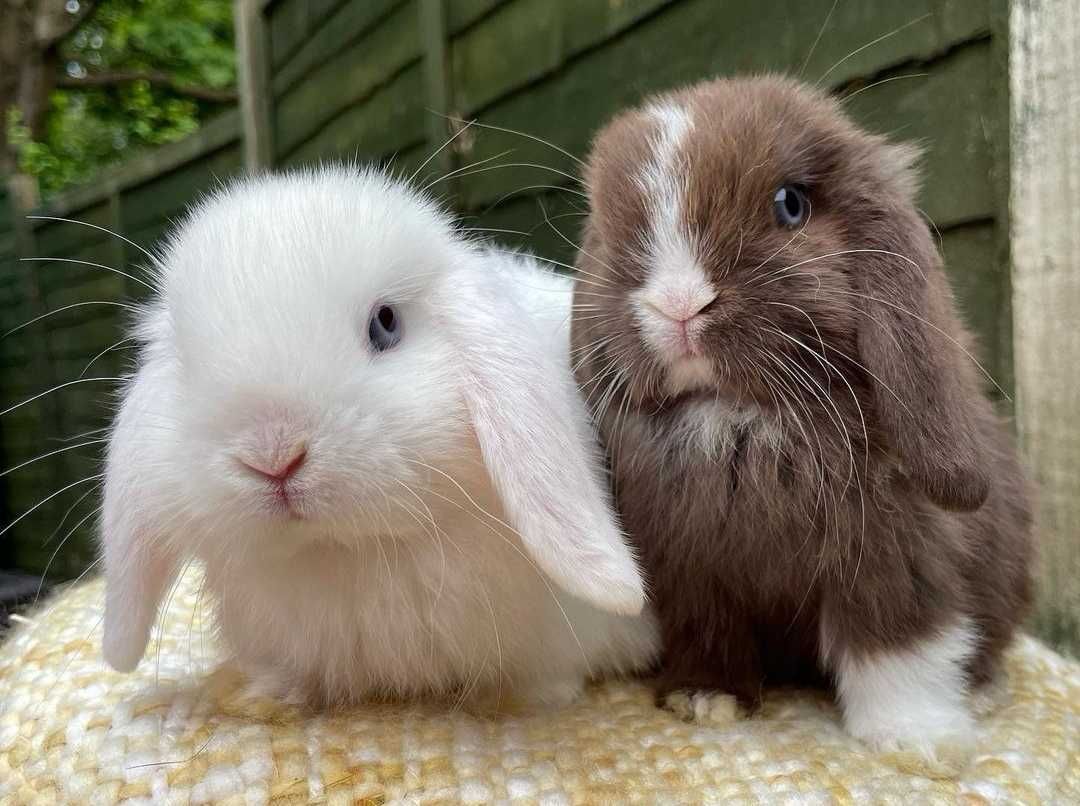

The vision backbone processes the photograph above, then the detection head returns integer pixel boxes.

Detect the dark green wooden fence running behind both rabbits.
[0,0,1071,652]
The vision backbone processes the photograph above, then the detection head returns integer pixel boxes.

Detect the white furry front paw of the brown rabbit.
[835,620,975,758]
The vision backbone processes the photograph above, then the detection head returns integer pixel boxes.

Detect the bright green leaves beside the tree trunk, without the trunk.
[9,0,237,194]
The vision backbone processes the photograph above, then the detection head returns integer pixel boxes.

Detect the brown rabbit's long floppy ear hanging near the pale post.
[856,197,989,511]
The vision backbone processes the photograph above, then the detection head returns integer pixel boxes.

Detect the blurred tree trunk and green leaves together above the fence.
[0,0,237,198]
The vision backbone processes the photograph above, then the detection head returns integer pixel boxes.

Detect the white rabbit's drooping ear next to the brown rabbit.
[443,267,645,614]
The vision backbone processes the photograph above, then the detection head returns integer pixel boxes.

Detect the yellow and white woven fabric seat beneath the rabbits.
[0,575,1080,806]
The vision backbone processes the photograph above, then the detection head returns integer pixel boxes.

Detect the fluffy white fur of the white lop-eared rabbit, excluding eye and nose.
[103,169,657,702]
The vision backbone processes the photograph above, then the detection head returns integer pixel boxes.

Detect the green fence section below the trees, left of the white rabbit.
[0,116,242,579]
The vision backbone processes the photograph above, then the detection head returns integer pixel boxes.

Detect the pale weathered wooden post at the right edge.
[1010,0,1080,654]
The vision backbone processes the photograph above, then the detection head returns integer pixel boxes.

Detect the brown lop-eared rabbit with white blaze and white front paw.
[572,77,1032,756]
